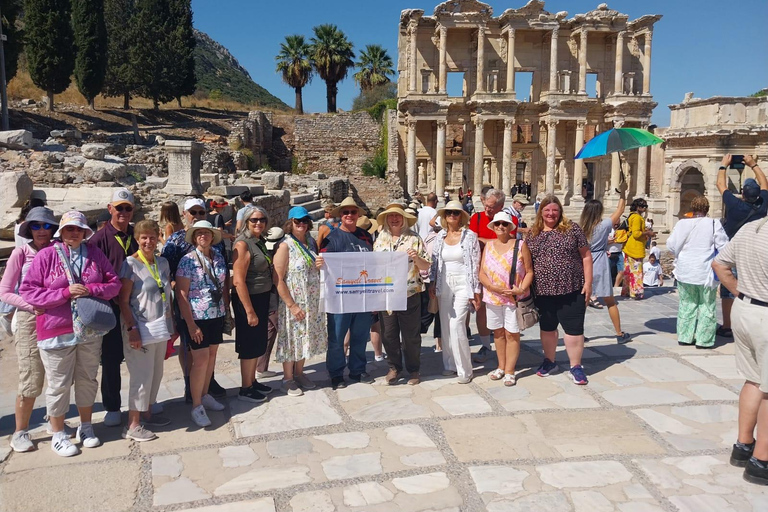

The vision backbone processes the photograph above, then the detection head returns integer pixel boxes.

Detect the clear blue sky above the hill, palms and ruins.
[192,0,768,126]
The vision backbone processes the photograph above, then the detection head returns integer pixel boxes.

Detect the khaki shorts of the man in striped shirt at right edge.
[731,299,768,393]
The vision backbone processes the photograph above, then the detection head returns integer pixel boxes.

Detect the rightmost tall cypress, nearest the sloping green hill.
[166,0,197,107]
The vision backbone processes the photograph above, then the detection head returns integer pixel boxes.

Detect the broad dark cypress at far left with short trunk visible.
[24,0,75,110]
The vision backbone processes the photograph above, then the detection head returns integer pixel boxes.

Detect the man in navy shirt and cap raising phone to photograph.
[717,154,768,338]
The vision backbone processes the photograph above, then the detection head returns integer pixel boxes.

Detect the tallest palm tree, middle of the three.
[311,24,355,112]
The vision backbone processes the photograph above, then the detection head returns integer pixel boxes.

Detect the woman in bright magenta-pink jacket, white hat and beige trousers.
[19,210,121,457]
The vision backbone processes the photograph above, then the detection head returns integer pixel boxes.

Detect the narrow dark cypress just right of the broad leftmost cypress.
[72,0,107,108]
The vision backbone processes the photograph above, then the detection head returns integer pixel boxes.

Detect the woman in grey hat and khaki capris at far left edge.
[0,206,59,452]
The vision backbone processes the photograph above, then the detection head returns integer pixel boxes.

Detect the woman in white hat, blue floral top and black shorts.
[176,220,229,427]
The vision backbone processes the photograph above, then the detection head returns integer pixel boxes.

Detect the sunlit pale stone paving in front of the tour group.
[0,288,768,512]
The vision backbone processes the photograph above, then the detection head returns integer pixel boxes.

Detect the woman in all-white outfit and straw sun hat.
[429,201,480,384]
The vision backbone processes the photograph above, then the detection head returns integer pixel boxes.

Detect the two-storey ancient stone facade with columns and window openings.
[390,0,661,208]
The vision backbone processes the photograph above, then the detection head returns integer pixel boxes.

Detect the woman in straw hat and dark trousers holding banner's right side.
[373,204,431,386]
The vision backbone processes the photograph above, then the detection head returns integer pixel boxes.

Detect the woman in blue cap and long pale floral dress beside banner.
[275,206,327,396]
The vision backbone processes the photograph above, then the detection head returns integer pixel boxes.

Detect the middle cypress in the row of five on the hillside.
[103,0,136,110]
